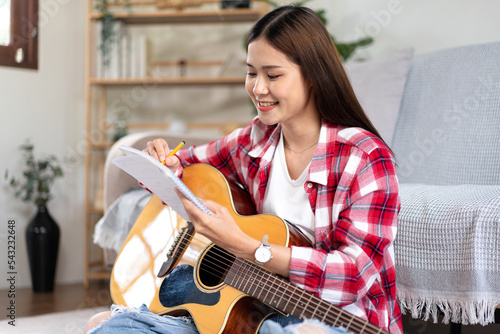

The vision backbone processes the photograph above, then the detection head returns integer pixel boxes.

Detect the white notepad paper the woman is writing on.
[112,146,212,220]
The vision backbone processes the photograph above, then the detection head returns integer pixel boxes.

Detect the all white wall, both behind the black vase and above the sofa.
[0,0,500,288]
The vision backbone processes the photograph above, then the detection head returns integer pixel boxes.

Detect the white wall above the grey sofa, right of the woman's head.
[310,0,500,58]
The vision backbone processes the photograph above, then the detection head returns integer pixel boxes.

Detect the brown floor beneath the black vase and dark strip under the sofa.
[0,281,500,334]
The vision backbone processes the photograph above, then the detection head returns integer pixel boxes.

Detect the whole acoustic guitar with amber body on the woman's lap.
[110,164,387,334]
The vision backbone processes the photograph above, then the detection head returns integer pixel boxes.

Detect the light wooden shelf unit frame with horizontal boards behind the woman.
[84,0,270,288]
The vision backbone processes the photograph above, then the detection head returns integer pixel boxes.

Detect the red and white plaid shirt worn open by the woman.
[178,118,403,333]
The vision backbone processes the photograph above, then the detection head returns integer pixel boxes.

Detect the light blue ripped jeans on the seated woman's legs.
[88,305,347,334]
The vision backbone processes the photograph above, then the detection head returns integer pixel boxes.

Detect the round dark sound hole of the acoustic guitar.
[199,245,234,287]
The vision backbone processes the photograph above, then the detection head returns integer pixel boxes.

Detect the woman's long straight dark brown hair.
[246,6,381,142]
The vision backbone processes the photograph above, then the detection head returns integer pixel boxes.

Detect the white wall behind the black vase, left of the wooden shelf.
[0,0,86,288]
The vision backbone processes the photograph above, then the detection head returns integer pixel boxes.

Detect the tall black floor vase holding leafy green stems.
[5,141,63,292]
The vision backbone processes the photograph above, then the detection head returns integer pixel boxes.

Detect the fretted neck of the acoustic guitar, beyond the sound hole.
[224,258,388,334]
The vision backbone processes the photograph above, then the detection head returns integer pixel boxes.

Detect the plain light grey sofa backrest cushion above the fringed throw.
[392,42,500,185]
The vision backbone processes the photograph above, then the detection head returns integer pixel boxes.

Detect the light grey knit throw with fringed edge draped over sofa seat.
[395,184,500,325]
